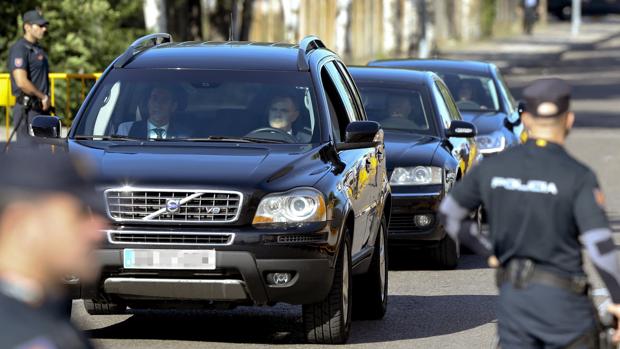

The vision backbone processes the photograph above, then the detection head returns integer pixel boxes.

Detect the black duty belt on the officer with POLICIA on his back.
[496,259,589,295]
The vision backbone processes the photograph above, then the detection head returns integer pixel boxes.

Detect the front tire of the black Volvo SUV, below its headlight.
[302,229,352,344]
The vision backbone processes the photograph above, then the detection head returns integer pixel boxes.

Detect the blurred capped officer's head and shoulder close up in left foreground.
[0,151,105,349]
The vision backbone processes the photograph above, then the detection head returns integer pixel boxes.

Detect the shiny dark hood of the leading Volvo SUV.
[69,141,330,188]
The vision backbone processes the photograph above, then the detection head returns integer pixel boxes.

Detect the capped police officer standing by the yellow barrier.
[8,10,51,140]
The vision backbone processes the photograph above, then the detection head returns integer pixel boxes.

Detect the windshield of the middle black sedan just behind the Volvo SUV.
[357,82,435,135]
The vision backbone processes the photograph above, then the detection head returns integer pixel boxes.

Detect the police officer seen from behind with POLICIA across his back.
[440,79,620,349]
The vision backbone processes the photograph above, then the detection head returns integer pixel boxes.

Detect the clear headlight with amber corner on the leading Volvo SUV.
[252,188,326,224]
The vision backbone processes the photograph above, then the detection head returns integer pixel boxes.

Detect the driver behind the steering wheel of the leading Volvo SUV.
[267,95,312,143]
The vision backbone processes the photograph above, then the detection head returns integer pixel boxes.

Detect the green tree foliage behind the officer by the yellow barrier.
[0,0,145,73]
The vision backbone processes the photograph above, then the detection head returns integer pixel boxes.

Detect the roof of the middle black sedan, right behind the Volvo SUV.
[348,67,435,85]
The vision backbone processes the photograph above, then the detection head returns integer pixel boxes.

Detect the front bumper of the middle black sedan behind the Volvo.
[388,186,446,246]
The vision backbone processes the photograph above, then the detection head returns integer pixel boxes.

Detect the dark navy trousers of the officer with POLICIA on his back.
[497,282,596,349]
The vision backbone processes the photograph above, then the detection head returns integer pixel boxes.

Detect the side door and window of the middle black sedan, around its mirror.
[433,79,476,175]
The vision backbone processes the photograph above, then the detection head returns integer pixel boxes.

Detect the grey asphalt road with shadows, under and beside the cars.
[73,20,620,348]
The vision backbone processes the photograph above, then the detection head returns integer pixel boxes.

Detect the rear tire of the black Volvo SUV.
[353,217,388,320]
